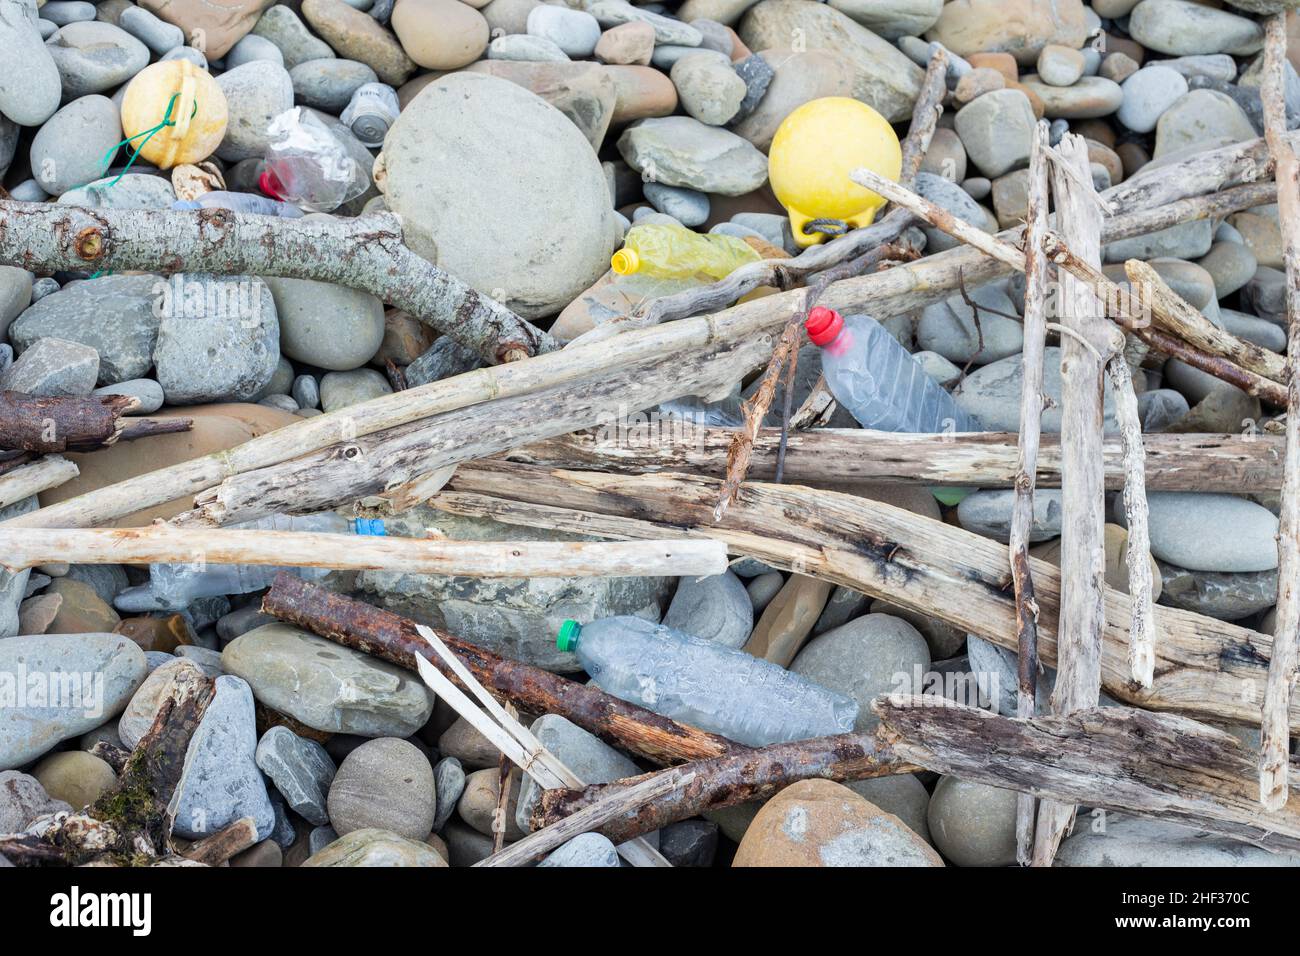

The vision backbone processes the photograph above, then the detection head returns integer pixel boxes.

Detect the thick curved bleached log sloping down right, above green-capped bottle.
[429,462,1300,728]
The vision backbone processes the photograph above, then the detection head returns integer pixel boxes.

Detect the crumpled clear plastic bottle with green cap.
[555,617,858,747]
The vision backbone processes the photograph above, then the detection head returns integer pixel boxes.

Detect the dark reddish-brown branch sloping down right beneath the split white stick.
[263,574,750,763]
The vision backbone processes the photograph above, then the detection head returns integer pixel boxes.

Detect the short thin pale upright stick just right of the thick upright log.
[1106,354,1156,687]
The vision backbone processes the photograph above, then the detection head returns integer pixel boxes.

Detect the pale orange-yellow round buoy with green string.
[122,60,230,169]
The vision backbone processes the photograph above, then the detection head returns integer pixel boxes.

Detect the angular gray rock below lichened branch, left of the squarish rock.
[9,276,164,385]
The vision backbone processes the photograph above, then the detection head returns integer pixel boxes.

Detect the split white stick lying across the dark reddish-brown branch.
[405,624,670,866]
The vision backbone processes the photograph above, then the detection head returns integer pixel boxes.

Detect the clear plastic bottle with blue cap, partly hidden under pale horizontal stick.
[113,511,386,611]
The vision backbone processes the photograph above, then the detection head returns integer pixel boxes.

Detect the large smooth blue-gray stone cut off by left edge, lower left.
[0,633,146,770]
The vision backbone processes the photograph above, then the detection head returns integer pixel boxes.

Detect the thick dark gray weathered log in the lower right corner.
[871,697,1300,852]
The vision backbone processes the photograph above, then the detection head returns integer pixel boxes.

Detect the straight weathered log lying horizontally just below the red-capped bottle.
[503,429,1284,493]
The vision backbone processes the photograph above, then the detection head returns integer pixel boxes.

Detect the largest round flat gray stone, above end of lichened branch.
[376,73,620,319]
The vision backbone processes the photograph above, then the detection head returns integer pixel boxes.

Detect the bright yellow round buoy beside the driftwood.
[767,96,902,246]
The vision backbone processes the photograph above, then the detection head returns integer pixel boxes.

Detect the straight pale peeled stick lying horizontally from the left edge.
[0,523,727,578]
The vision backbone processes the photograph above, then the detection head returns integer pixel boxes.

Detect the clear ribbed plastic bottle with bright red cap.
[805,306,980,434]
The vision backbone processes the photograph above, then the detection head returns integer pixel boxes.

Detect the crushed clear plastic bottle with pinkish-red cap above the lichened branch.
[260,107,371,212]
